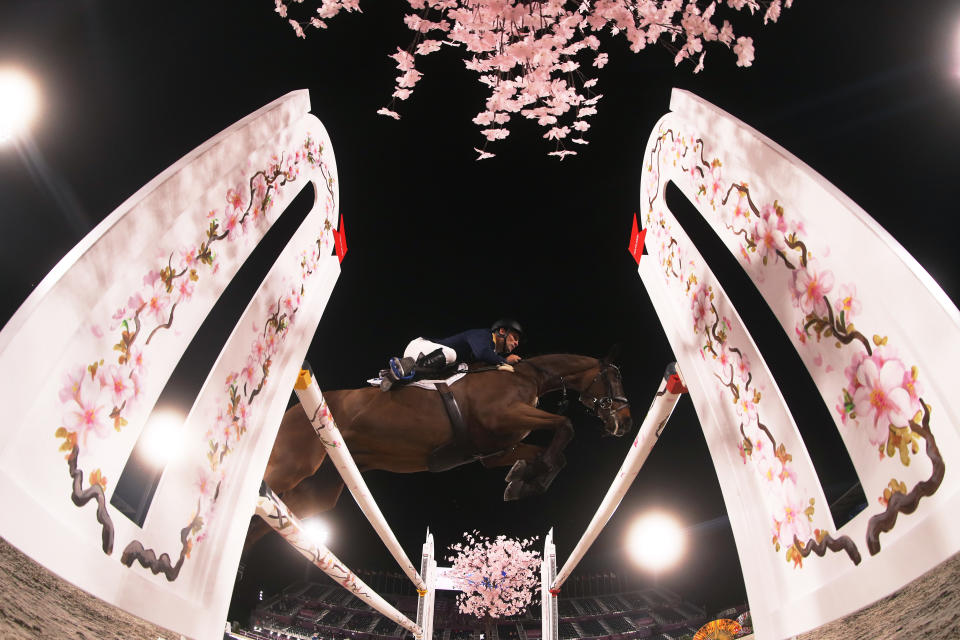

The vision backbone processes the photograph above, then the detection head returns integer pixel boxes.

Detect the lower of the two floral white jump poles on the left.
[256,485,423,640]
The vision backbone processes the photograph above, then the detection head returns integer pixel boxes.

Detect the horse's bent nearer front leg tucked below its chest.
[503,405,573,501]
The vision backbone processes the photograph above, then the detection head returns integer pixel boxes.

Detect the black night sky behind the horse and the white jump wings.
[0,0,960,624]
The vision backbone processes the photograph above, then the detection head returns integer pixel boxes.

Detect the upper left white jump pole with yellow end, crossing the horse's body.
[294,369,427,595]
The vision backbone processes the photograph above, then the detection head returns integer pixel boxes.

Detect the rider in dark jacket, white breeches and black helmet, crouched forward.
[380,318,523,391]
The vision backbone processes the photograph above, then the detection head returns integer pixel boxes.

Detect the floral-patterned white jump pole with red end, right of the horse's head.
[542,362,687,592]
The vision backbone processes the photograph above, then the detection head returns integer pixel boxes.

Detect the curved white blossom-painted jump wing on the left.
[0,91,339,638]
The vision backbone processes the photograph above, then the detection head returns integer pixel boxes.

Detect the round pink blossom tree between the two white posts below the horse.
[447,531,540,620]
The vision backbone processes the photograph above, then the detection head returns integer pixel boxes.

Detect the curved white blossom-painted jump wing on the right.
[639,90,960,638]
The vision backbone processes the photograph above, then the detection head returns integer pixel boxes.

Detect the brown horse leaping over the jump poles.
[244,354,632,551]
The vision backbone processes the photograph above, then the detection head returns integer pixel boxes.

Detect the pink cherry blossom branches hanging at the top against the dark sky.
[274,0,793,160]
